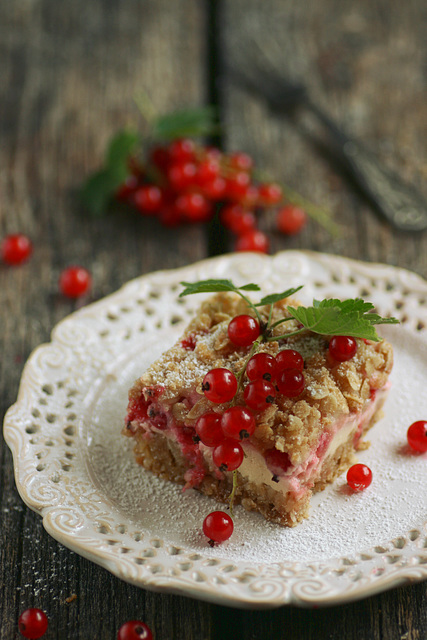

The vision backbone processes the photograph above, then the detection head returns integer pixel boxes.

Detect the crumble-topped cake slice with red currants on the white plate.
[123,293,393,526]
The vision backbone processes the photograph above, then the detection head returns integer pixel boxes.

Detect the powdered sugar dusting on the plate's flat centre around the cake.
[86,327,427,563]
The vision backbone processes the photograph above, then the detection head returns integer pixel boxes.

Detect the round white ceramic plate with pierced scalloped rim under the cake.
[4,251,427,608]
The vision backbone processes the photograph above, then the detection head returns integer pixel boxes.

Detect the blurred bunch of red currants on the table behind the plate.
[116,138,307,253]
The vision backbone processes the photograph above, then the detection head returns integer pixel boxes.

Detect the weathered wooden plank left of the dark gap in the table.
[0,0,210,640]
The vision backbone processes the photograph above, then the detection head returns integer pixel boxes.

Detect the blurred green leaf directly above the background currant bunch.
[152,106,219,140]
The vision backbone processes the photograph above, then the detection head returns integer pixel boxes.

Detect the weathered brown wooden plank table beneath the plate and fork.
[0,0,427,640]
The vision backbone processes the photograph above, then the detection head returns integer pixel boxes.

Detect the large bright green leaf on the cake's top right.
[288,298,399,342]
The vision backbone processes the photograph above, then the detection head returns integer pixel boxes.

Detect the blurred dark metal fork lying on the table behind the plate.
[229,69,427,231]
